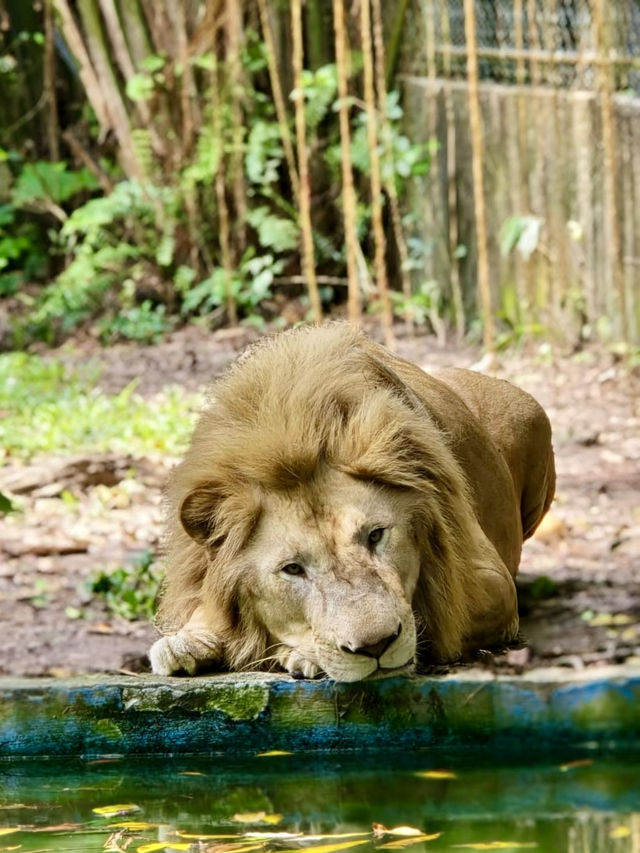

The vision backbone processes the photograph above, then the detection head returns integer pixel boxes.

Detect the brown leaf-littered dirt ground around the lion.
[0,328,640,676]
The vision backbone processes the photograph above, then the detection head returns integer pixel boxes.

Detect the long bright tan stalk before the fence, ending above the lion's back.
[464,0,495,353]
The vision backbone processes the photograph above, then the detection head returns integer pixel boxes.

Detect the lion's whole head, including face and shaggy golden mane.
[154,325,490,681]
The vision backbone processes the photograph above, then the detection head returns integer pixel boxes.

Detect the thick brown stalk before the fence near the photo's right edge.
[592,0,629,341]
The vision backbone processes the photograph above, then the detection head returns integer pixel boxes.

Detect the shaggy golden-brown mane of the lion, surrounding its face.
[157,324,500,669]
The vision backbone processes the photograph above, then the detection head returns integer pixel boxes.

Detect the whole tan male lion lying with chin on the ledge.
[150,323,555,682]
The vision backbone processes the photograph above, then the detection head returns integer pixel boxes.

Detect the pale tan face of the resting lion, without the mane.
[235,469,419,681]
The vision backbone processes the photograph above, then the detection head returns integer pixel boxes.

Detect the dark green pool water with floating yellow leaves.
[0,750,640,853]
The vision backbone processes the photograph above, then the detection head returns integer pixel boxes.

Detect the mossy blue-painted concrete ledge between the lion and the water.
[0,667,640,757]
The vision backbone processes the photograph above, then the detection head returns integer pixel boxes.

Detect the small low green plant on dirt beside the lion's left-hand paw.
[88,548,162,621]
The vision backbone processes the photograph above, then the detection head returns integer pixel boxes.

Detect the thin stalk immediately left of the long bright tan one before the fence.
[440,0,466,344]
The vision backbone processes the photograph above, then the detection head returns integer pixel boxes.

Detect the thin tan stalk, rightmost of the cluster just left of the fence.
[371,0,414,334]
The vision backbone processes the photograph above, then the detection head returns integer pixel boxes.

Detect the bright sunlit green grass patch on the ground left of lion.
[0,353,201,464]
